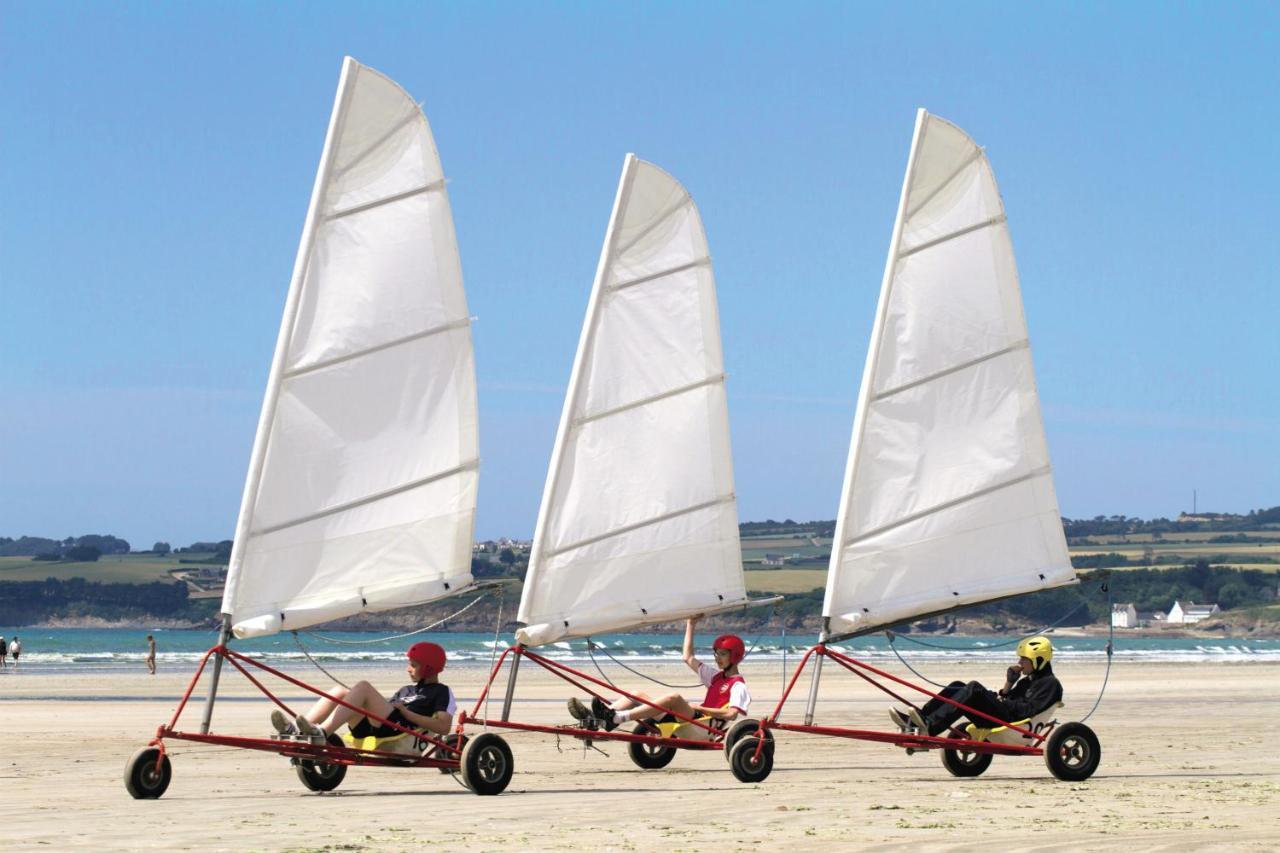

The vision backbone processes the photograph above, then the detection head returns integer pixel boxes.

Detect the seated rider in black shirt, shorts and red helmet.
[271,643,458,738]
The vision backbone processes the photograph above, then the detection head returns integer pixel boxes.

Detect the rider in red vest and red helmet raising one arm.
[568,616,751,731]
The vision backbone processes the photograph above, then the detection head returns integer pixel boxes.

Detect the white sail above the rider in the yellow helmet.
[823,110,1075,637]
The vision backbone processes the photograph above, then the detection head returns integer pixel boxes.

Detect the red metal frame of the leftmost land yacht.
[147,646,461,770]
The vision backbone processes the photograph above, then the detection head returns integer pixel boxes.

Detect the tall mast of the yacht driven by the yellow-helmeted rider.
[804,108,928,725]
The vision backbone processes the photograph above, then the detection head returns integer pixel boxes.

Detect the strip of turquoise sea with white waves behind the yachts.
[0,626,1280,674]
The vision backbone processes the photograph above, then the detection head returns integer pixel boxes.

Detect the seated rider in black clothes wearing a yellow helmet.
[888,637,1062,735]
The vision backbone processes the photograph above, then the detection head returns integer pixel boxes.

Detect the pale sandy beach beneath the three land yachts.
[0,653,1280,850]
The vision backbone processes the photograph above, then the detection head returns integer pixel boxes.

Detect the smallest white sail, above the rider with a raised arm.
[517,155,746,646]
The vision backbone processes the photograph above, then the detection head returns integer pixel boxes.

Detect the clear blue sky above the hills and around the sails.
[0,1,1280,547]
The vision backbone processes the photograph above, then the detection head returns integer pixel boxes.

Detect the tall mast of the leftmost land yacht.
[200,56,357,734]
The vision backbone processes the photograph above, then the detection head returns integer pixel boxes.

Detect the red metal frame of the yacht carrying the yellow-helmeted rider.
[755,643,1048,758]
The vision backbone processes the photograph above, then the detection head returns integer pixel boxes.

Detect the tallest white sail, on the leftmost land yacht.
[223,58,479,637]
